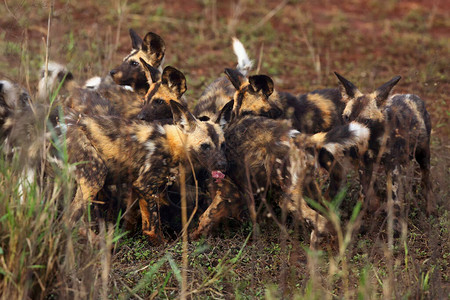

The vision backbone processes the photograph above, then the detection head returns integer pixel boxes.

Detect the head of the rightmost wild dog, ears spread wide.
[335,72,401,126]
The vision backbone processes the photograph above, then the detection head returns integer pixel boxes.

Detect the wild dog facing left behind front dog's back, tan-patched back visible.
[225,69,343,198]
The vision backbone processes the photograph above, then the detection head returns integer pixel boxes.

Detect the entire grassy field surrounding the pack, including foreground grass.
[0,0,450,299]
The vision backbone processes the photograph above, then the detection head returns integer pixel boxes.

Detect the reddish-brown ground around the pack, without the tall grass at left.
[0,0,450,299]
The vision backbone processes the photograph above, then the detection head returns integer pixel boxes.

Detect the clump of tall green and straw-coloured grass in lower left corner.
[0,87,116,299]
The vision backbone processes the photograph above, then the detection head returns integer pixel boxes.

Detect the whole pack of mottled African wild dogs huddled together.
[0,29,435,245]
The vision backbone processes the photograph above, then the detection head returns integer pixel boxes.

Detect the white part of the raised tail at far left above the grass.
[37,61,70,101]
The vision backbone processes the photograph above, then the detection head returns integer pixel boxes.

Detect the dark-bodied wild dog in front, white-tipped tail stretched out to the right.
[192,75,369,246]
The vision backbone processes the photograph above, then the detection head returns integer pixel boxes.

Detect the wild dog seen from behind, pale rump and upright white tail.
[194,38,253,120]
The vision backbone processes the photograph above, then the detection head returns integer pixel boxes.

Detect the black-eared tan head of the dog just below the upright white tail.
[225,69,282,122]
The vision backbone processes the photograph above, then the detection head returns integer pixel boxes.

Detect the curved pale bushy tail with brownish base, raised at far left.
[37,62,77,102]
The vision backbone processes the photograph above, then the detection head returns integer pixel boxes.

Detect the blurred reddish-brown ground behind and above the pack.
[0,0,450,135]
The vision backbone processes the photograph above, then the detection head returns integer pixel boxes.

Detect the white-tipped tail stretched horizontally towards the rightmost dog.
[308,122,370,156]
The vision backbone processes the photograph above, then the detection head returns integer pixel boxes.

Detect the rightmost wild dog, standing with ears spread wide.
[335,73,435,234]
